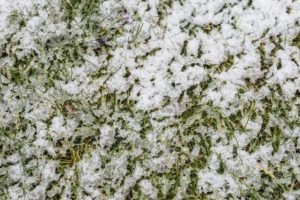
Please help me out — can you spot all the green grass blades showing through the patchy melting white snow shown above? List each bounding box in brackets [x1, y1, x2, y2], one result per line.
[0, 0, 300, 199]
